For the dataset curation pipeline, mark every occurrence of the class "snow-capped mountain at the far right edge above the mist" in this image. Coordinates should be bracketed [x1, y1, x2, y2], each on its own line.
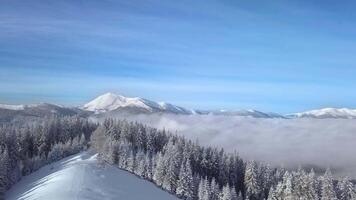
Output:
[287, 108, 356, 119]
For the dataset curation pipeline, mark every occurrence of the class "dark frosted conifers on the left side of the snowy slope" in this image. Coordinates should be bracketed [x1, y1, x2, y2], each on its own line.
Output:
[0, 117, 97, 199]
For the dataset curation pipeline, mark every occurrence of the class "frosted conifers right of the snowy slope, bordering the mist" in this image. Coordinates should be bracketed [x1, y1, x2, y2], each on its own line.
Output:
[91, 119, 356, 200]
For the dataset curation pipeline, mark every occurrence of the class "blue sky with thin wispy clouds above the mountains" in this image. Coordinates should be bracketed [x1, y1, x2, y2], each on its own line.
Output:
[0, 0, 356, 113]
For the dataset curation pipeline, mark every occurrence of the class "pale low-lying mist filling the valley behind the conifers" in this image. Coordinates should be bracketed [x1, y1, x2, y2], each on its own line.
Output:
[93, 114, 356, 178]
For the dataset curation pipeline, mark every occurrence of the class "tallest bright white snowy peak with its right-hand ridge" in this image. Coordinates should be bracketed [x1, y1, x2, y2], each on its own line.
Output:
[82, 93, 192, 114]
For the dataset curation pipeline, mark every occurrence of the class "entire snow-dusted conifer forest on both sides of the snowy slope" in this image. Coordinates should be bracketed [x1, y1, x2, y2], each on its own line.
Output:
[0, 117, 356, 200]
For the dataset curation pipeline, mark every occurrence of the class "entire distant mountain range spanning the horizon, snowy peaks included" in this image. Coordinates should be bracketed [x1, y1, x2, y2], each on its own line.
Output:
[0, 93, 356, 122]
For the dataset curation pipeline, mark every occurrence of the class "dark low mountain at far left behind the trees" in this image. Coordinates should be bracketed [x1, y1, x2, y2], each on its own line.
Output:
[0, 103, 89, 123]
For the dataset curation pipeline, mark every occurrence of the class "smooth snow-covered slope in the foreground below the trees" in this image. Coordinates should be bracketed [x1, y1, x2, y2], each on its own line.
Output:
[6, 152, 181, 200]
